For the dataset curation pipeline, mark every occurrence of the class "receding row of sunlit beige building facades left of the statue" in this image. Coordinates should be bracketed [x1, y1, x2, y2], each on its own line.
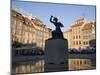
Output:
[11, 9, 51, 48]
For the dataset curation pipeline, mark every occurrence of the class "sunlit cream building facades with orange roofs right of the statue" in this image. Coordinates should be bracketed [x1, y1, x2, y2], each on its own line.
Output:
[64, 18, 96, 50]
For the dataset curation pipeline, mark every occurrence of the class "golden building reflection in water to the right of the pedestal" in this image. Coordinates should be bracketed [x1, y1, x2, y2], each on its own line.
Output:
[69, 59, 92, 70]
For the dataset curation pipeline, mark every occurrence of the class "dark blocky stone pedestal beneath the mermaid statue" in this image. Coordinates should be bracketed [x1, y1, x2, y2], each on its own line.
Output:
[45, 39, 68, 72]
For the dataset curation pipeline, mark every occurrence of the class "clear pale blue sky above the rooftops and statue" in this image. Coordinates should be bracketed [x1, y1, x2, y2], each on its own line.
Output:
[11, 1, 96, 32]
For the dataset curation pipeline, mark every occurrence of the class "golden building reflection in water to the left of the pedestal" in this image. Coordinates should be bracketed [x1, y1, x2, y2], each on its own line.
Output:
[15, 60, 44, 73]
